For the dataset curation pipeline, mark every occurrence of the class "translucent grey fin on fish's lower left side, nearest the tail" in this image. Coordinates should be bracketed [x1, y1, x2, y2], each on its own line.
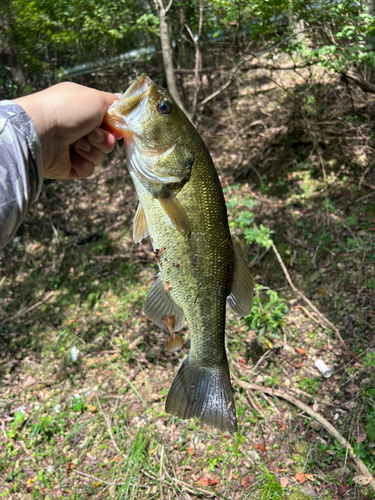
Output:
[143, 273, 185, 332]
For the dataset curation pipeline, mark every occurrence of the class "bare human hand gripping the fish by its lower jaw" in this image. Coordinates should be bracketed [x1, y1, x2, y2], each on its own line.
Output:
[14, 82, 121, 179]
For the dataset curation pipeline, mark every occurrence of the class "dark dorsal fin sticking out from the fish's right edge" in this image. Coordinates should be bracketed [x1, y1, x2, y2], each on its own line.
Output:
[227, 249, 254, 316]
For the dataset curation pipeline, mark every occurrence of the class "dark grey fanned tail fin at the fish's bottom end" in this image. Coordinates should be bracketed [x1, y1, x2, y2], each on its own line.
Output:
[165, 356, 237, 432]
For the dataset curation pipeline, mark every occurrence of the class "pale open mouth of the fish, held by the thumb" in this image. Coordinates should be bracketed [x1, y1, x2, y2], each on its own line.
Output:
[103, 73, 153, 132]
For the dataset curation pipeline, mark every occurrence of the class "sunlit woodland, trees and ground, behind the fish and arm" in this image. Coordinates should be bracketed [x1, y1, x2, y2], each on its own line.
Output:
[0, 0, 375, 500]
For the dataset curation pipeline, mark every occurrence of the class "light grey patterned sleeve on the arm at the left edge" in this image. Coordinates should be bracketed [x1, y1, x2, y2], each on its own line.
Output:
[0, 101, 43, 249]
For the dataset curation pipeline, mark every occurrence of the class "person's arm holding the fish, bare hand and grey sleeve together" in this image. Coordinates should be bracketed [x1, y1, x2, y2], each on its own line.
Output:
[0, 83, 116, 249]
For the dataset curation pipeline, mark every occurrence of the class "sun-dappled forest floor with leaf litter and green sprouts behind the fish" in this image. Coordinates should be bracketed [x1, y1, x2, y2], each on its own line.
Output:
[0, 67, 375, 500]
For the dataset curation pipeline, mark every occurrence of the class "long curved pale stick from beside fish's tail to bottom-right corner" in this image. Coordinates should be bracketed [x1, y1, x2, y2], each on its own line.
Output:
[237, 380, 375, 491]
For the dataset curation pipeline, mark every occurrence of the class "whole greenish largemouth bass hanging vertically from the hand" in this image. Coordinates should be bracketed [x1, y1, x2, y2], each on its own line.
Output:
[104, 74, 254, 432]
